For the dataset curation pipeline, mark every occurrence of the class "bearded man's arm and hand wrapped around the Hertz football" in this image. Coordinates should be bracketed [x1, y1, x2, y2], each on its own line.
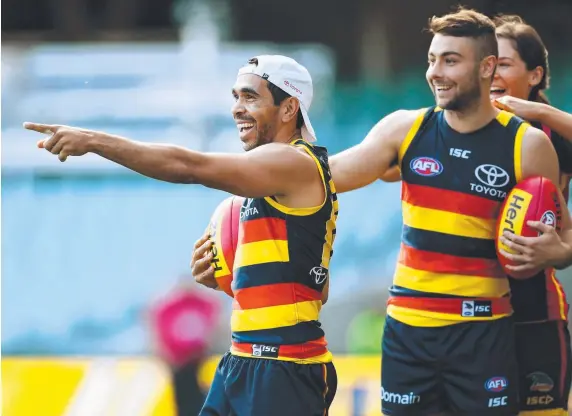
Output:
[501, 128, 572, 271]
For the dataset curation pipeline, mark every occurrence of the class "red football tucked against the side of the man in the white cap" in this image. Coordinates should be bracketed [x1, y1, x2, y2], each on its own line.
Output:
[209, 196, 244, 297]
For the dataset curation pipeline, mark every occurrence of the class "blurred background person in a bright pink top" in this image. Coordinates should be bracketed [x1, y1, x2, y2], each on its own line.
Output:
[148, 284, 220, 416]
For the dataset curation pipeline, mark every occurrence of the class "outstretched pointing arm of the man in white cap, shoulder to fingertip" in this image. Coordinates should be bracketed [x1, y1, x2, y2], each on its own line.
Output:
[24, 123, 317, 198]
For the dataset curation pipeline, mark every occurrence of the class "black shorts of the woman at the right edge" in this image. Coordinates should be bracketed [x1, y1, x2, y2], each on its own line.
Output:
[515, 321, 571, 415]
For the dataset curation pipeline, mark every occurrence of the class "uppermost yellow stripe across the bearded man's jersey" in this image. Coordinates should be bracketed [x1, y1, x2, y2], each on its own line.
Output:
[402, 201, 496, 240]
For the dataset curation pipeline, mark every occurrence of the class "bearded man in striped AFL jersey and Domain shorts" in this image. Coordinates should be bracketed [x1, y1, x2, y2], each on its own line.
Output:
[331, 10, 572, 416]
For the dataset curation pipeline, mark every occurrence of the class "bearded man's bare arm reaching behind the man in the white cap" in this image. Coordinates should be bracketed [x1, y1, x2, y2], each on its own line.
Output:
[330, 110, 420, 193]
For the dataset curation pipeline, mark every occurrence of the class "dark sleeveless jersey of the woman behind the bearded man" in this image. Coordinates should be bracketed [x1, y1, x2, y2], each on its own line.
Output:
[509, 123, 572, 323]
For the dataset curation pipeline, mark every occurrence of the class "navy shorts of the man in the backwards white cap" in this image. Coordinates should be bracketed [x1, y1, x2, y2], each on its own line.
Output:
[199, 353, 338, 416]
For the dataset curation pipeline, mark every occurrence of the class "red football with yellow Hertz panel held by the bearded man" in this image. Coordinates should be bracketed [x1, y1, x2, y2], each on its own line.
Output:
[496, 176, 562, 279]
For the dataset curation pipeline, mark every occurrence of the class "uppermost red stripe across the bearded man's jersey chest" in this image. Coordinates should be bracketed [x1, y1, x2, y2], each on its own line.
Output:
[401, 182, 501, 219]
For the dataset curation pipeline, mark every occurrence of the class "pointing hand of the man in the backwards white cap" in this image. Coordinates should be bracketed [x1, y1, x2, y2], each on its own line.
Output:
[24, 123, 96, 162]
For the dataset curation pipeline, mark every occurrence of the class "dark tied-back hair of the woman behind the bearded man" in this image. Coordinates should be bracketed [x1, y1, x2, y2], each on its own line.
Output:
[494, 15, 550, 104]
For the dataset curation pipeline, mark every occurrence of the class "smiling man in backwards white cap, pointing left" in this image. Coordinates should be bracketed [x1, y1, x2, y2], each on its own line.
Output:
[25, 55, 338, 416]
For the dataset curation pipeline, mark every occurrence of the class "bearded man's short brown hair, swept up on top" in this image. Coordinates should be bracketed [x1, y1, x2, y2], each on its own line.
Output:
[428, 7, 499, 59]
